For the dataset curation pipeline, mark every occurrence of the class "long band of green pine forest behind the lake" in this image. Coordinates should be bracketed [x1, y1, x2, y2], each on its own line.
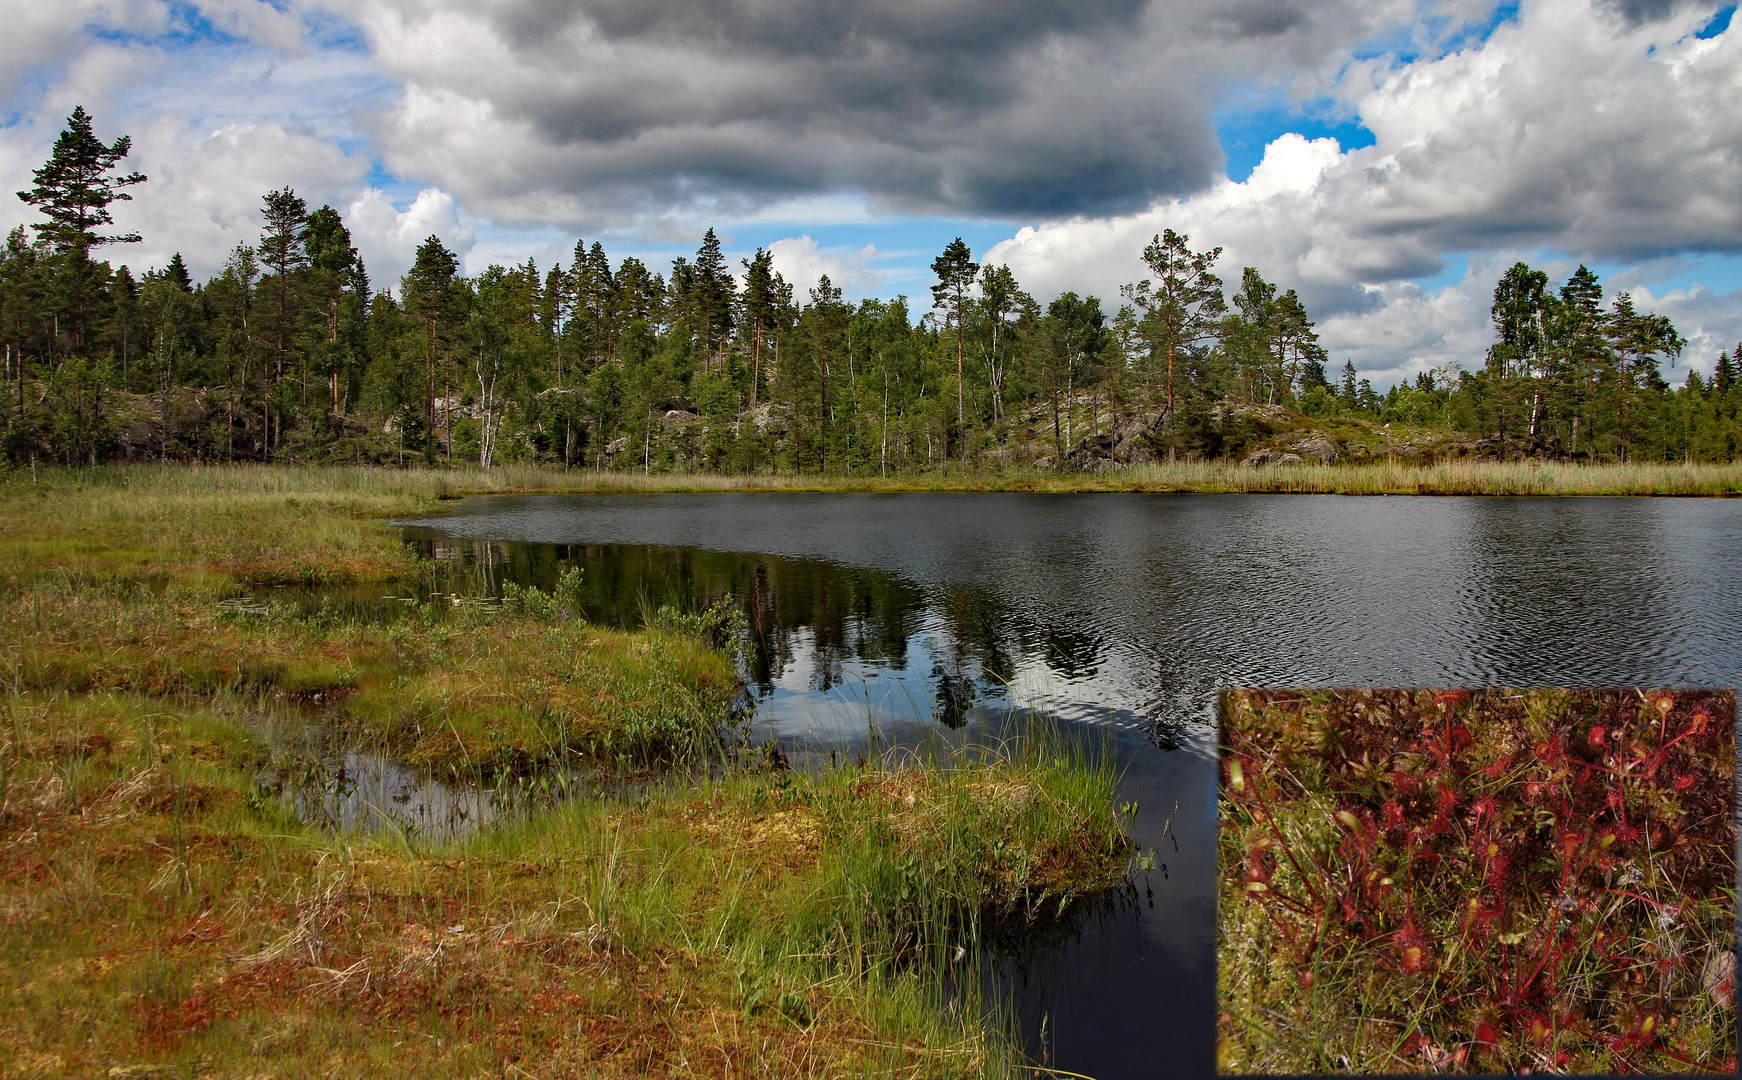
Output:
[10, 108, 1742, 476]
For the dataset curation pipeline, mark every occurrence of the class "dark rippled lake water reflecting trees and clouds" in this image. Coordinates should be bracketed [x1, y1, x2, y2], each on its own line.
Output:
[398, 495, 1742, 1080]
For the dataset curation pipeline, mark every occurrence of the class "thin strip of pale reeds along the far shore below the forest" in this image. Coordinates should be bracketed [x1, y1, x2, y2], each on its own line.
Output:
[7, 460, 1742, 501]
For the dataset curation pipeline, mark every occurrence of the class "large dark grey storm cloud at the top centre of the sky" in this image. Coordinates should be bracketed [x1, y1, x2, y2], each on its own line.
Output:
[376, 0, 1413, 218]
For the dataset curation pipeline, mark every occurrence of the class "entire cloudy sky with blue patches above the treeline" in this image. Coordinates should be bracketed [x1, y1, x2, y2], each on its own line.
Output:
[0, 0, 1742, 387]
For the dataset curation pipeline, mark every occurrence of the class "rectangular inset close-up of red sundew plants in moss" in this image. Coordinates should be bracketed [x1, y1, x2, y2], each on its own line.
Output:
[1218, 690, 1737, 1075]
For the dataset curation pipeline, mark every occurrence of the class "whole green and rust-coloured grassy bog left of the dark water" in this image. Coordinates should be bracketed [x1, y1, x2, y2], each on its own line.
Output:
[0, 469, 1131, 1078]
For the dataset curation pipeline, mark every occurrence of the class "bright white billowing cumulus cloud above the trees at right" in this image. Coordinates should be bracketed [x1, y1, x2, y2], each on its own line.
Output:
[986, 0, 1742, 381]
